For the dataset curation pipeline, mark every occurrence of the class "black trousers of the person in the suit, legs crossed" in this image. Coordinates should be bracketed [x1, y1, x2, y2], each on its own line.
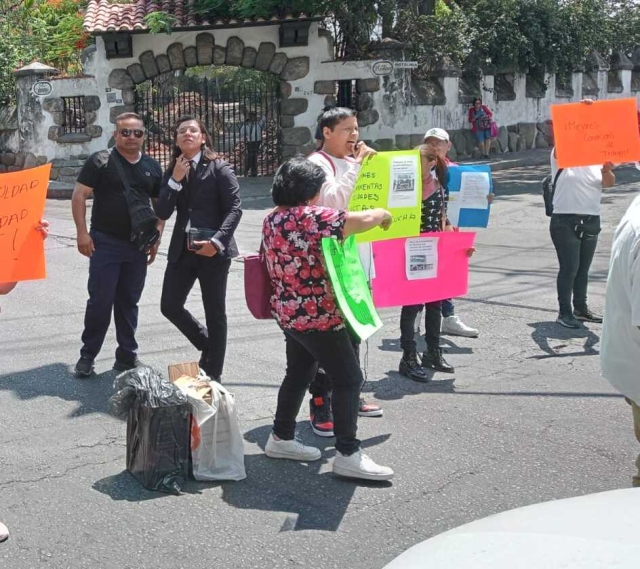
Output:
[160, 251, 231, 378]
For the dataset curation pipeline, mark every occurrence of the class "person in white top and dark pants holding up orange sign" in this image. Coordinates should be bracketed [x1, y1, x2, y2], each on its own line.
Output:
[549, 138, 616, 328]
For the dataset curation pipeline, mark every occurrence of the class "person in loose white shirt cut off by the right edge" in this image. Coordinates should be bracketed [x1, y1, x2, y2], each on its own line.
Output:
[600, 196, 640, 487]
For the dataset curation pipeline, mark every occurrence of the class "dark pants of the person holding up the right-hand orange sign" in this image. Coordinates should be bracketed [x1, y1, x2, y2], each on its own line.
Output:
[549, 214, 600, 315]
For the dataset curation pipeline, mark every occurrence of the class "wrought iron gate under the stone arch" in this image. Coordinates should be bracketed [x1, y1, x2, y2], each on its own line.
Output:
[136, 72, 281, 176]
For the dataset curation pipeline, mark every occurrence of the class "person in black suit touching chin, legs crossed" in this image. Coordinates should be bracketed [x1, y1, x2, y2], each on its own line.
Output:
[156, 116, 242, 381]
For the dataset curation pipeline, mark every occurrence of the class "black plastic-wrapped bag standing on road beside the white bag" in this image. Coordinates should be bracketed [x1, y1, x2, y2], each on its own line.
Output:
[109, 366, 191, 494]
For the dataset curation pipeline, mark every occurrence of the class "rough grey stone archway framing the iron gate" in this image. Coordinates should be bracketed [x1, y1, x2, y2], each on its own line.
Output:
[108, 32, 313, 170]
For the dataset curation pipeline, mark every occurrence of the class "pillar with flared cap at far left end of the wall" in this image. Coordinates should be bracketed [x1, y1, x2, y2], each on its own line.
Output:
[14, 62, 59, 158]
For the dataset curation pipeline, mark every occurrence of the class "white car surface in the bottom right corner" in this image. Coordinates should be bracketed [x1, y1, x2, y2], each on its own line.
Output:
[384, 488, 640, 569]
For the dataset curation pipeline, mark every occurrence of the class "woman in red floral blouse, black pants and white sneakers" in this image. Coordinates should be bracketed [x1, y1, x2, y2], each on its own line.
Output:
[263, 157, 393, 480]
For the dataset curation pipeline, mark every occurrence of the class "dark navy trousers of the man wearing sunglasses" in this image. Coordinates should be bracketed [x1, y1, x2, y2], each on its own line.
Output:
[80, 231, 147, 363]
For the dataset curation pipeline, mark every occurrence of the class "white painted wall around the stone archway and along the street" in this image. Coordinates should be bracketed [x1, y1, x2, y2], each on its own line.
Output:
[12, 23, 640, 159]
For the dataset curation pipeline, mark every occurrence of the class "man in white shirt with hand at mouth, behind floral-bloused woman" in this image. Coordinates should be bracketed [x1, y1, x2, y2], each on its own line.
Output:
[308, 107, 382, 437]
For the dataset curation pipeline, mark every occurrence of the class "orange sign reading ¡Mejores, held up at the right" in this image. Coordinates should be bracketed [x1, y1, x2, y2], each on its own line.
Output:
[551, 99, 640, 168]
